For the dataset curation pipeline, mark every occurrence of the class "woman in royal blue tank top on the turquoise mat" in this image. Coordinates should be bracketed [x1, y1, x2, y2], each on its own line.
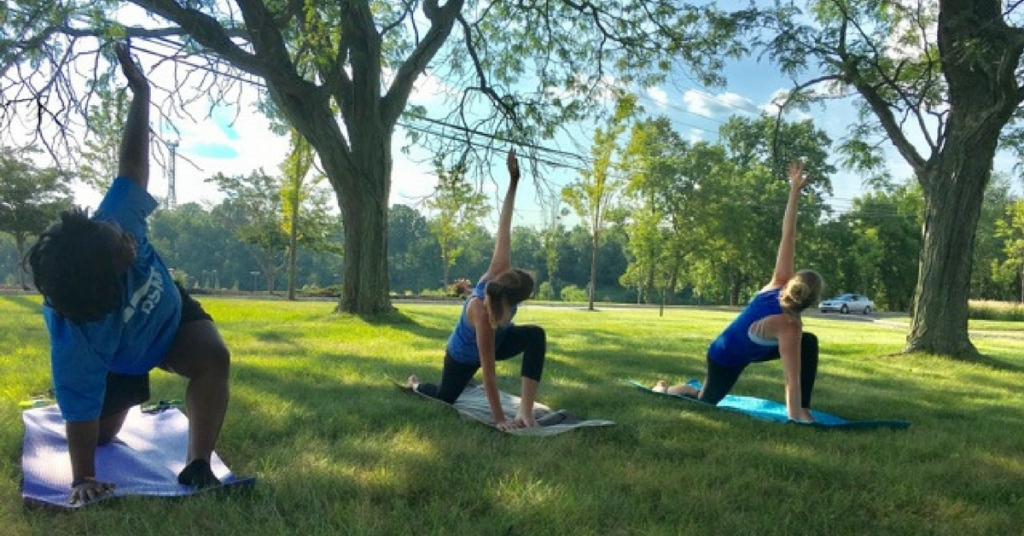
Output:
[653, 163, 823, 422]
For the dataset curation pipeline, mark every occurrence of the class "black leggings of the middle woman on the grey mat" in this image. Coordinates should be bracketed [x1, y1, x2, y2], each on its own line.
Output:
[417, 326, 548, 404]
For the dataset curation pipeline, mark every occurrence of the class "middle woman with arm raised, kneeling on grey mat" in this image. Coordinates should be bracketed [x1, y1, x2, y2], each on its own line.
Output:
[407, 151, 547, 430]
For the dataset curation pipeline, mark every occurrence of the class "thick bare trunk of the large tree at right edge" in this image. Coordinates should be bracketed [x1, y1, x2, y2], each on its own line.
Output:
[906, 0, 1024, 358]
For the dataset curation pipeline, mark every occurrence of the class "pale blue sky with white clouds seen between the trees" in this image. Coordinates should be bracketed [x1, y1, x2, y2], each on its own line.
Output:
[51, 9, 1015, 226]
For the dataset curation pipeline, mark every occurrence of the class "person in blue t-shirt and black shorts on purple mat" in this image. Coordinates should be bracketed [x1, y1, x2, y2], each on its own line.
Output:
[27, 45, 229, 503]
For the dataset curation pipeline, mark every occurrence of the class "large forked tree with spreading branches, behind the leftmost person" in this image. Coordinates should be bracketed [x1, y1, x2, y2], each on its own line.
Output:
[0, 0, 751, 314]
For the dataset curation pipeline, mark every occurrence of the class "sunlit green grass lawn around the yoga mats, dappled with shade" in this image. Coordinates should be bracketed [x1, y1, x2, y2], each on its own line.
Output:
[0, 296, 1024, 535]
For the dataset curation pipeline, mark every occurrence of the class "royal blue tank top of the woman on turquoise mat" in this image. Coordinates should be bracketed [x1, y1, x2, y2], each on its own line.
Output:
[708, 288, 782, 367]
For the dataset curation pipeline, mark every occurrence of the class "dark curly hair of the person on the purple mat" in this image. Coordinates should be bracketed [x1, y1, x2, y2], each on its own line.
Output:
[23, 208, 135, 323]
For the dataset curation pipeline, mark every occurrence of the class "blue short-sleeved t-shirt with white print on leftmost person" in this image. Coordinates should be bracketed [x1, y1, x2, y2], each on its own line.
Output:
[43, 177, 181, 421]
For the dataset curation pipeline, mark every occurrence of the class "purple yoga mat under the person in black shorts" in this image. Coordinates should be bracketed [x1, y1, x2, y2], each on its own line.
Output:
[22, 406, 256, 508]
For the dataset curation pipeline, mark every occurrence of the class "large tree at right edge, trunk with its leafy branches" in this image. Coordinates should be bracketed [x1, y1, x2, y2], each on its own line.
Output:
[761, 0, 1024, 357]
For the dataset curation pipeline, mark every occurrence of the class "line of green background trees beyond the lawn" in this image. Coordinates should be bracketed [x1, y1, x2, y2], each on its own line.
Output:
[6, 117, 1024, 311]
